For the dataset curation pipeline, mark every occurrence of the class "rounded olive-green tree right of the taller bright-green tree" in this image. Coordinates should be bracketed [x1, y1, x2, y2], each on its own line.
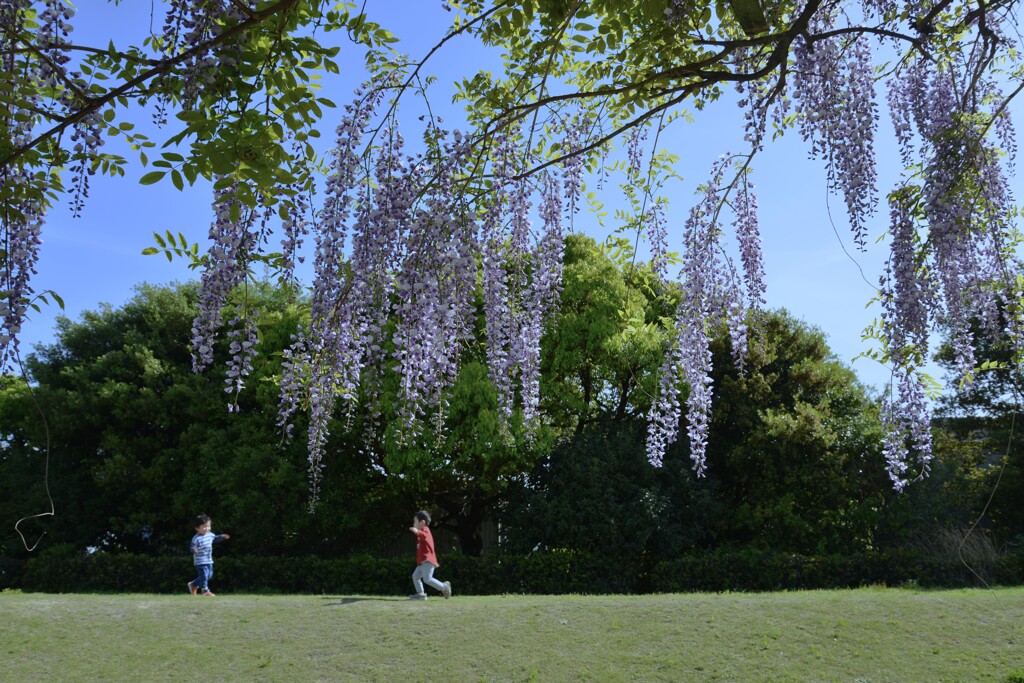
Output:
[712, 311, 893, 552]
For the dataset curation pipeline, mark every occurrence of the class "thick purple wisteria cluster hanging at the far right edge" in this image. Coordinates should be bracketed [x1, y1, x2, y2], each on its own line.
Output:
[881, 53, 1021, 475]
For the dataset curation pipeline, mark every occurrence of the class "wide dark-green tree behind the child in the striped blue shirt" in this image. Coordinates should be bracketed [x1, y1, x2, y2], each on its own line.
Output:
[0, 285, 412, 555]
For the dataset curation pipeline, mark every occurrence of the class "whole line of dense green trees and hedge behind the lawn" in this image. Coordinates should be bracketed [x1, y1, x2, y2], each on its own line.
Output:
[0, 236, 1024, 581]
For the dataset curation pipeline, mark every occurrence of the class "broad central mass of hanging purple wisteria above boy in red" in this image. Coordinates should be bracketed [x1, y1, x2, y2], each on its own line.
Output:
[268, 88, 581, 502]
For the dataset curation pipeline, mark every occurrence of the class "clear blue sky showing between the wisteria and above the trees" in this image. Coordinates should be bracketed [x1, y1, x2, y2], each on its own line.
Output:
[23, 0, 958, 395]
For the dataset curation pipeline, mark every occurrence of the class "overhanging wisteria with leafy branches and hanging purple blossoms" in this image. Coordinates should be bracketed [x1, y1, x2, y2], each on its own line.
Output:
[0, 0, 1022, 492]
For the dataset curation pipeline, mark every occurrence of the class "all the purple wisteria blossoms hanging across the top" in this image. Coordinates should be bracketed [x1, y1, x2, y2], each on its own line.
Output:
[0, 0, 1024, 496]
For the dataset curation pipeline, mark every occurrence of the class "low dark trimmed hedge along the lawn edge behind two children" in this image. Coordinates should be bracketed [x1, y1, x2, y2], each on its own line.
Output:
[0, 549, 1024, 595]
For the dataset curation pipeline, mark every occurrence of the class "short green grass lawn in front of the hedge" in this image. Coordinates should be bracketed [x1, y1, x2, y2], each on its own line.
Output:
[0, 587, 1024, 683]
